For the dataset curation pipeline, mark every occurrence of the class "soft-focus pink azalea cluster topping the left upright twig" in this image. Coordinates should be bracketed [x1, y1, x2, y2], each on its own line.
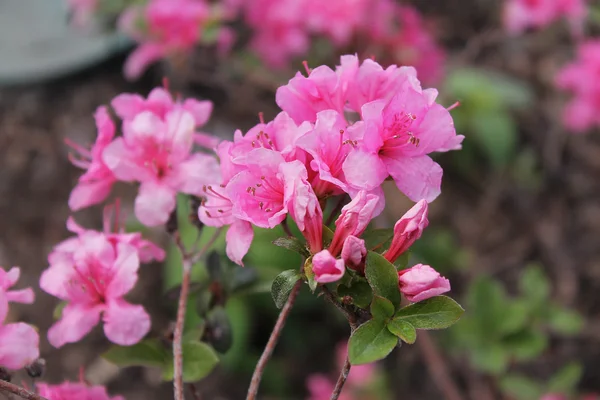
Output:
[69, 88, 219, 226]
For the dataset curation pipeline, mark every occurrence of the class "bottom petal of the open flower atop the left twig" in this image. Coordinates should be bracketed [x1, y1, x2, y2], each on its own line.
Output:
[135, 182, 176, 226]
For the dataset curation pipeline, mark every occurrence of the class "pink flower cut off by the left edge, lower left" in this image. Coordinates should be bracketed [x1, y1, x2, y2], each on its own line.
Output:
[0, 267, 40, 369]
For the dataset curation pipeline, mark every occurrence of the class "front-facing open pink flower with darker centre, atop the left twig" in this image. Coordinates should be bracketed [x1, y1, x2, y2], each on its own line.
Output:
[103, 109, 219, 226]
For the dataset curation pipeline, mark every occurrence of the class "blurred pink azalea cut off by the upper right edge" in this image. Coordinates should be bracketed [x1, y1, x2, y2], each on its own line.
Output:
[556, 40, 600, 133]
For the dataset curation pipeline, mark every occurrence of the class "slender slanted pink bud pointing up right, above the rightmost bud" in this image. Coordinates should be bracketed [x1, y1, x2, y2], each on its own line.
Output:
[384, 200, 429, 263]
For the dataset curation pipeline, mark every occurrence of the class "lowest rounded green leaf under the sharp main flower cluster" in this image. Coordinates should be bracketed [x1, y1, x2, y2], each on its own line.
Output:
[348, 319, 398, 365]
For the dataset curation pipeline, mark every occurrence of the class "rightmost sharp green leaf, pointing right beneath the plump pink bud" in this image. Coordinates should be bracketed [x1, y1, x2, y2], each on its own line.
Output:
[392, 296, 465, 329]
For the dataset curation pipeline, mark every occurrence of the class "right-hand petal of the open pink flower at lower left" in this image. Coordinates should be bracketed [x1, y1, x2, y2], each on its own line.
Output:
[105, 243, 140, 299]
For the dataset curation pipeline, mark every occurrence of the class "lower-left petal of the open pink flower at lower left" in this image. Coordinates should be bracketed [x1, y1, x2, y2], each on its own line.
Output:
[48, 303, 104, 348]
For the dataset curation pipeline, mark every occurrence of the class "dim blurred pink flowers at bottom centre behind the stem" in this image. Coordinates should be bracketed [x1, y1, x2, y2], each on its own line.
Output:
[306, 343, 377, 400]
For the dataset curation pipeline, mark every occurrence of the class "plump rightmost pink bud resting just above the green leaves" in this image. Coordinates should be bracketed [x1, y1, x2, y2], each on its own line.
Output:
[398, 264, 450, 303]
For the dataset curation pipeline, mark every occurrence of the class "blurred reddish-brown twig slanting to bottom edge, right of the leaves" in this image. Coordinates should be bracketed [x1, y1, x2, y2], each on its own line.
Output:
[417, 331, 464, 400]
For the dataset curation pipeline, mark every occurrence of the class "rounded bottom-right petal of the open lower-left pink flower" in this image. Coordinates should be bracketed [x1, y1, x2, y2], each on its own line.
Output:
[104, 300, 150, 346]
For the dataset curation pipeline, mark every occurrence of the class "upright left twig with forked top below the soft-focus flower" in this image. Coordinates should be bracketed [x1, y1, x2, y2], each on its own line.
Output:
[173, 228, 221, 400]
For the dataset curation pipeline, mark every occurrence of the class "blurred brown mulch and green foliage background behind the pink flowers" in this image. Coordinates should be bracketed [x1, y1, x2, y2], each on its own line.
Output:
[0, 0, 600, 400]
